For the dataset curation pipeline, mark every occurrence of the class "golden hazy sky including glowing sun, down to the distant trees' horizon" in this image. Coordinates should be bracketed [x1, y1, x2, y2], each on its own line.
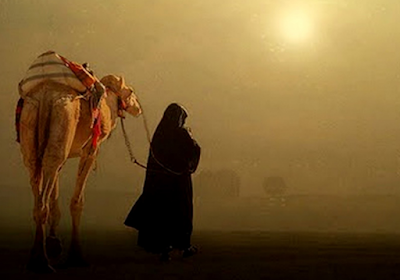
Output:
[0, 0, 400, 194]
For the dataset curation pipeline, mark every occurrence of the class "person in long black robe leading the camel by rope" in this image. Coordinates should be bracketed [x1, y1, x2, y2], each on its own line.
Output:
[125, 103, 200, 260]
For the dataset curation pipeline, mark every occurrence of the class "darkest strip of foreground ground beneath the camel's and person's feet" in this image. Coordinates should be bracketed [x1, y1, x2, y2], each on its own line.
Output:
[0, 229, 400, 279]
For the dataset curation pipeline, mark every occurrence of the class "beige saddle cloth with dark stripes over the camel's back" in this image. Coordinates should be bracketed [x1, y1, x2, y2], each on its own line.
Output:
[19, 51, 96, 98]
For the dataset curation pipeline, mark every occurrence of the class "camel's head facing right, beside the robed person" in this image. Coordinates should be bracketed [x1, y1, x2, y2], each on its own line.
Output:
[100, 75, 142, 117]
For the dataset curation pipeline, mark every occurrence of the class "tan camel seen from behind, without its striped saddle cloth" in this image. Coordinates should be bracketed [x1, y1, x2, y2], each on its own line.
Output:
[19, 53, 141, 273]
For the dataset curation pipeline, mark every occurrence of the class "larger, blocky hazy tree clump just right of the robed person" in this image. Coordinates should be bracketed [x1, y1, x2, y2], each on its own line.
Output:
[194, 170, 240, 198]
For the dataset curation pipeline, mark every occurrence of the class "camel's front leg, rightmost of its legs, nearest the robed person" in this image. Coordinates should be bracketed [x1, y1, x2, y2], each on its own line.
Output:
[68, 146, 97, 266]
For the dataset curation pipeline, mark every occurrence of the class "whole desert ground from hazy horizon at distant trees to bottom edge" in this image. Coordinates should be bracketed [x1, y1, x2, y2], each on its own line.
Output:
[0, 188, 400, 279]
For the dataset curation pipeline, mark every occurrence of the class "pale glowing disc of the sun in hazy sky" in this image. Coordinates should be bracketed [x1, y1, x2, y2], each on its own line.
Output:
[279, 10, 313, 43]
